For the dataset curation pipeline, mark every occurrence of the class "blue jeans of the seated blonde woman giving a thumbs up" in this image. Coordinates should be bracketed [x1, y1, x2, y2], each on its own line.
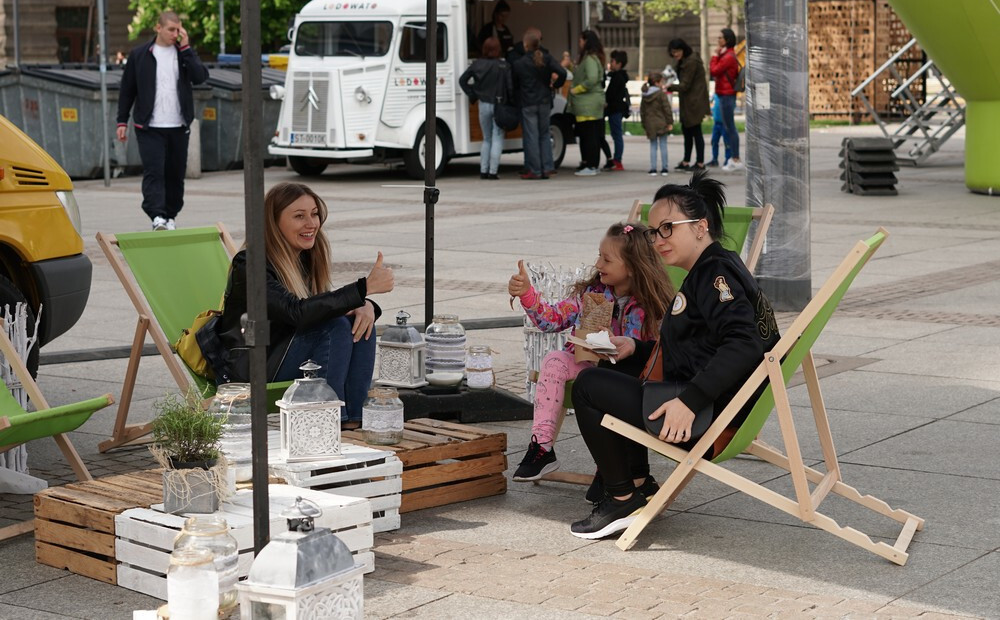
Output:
[274, 316, 375, 422]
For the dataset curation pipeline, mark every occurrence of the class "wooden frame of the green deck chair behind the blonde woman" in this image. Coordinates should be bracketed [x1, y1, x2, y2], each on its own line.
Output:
[97, 222, 237, 452]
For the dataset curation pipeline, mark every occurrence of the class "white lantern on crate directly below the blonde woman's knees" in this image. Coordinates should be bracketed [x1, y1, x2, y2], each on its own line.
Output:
[278, 360, 344, 462]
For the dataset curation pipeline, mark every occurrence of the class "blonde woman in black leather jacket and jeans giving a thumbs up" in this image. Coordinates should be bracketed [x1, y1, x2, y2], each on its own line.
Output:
[207, 183, 393, 428]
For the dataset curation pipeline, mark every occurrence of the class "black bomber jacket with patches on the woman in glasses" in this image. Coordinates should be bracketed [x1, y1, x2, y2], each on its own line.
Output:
[626, 242, 780, 426]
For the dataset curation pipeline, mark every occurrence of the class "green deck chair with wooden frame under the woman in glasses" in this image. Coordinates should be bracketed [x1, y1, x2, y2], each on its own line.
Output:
[602, 228, 924, 565]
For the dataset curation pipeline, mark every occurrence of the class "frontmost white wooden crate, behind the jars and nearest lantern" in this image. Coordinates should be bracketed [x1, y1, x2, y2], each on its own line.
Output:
[115, 484, 375, 600]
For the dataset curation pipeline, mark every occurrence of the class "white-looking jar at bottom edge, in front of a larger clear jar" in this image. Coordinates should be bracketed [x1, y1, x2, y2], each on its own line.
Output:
[167, 548, 219, 620]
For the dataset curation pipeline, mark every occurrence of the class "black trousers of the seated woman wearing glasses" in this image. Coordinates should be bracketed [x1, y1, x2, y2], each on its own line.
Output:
[573, 368, 649, 496]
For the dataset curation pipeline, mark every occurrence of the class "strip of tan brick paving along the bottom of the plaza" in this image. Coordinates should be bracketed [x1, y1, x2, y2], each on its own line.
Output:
[371, 533, 969, 620]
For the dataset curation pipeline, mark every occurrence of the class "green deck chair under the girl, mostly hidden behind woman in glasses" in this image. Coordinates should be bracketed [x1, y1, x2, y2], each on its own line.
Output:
[536, 200, 774, 485]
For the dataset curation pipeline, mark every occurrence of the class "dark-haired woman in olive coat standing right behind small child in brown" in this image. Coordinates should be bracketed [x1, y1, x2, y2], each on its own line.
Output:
[667, 39, 711, 170]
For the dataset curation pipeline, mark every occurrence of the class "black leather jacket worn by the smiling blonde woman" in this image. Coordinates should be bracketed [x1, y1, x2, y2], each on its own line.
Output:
[215, 250, 382, 383]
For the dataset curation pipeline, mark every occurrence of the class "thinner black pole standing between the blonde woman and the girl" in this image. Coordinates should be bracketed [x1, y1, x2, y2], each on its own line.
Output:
[424, 0, 443, 325]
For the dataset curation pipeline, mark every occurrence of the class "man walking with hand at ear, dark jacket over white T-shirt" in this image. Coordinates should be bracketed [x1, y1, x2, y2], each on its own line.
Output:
[118, 11, 208, 230]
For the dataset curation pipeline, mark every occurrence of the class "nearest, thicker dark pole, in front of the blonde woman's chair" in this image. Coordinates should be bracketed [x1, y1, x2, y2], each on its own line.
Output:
[240, 0, 270, 555]
